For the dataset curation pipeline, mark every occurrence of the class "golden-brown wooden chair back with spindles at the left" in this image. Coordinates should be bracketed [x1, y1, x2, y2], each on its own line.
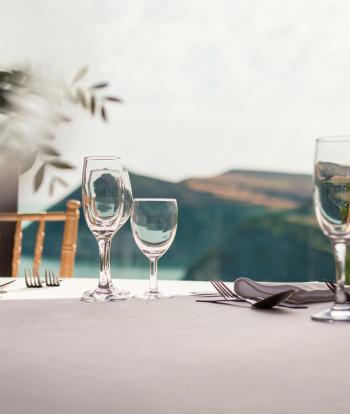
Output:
[0, 200, 80, 277]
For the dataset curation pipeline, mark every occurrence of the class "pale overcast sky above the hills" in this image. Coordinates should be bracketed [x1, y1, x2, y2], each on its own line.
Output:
[0, 0, 350, 206]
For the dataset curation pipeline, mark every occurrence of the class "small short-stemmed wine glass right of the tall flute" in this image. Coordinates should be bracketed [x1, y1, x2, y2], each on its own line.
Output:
[130, 198, 178, 299]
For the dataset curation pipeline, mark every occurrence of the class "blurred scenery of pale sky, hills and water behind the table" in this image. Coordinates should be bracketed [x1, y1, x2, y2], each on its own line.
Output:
[0, 0, 350, 281]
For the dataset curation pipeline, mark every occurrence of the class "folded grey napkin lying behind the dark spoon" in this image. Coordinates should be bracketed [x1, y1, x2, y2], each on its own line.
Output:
[234, 277, 334, 304]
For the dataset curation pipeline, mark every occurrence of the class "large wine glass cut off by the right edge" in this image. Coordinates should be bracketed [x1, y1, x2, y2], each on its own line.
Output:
[312, 136, 350, 321]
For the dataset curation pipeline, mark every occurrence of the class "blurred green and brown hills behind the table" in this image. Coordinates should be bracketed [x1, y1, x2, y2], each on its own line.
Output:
[23, 171, 332, 280]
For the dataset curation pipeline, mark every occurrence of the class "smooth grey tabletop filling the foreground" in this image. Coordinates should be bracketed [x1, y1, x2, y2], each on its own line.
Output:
[0, 297, 350, 414]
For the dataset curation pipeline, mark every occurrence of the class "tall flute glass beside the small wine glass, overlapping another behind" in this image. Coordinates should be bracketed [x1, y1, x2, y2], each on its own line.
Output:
[81, 157, 126, 302]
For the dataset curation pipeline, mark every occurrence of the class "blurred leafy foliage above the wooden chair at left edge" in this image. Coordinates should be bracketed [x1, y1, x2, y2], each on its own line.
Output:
[0, 66, 121, 193]
